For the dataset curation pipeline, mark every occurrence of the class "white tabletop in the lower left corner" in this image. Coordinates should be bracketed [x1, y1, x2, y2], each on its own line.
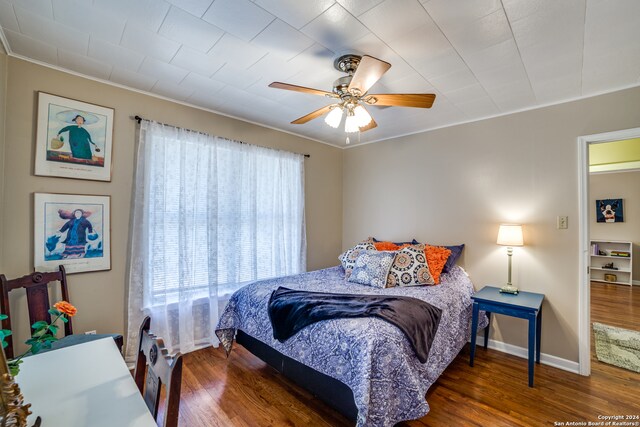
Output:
[16, 338, 156, 427]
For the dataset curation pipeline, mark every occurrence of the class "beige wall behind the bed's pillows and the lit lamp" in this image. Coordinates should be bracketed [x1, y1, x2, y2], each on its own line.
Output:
[342, 88, 640, 361]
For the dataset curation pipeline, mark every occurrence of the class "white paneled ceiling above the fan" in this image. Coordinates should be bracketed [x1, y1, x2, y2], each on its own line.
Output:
[0, 0, 640, 146]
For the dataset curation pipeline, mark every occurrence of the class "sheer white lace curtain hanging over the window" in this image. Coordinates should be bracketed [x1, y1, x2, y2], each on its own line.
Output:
[126, 121, 306, 361]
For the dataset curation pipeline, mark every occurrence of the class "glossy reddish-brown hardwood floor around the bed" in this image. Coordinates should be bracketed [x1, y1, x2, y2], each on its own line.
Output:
[171, 282, 640, 427]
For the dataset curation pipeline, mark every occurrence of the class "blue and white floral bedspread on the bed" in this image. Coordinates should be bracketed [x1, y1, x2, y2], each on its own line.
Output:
[216, 266, 487, 427]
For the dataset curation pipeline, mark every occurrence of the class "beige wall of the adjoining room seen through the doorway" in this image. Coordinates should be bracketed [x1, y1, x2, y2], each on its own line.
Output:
[589, 171, 640, 280]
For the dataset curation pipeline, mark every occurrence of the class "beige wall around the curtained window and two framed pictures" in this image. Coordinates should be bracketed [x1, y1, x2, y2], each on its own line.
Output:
[2, 58, 342, 352]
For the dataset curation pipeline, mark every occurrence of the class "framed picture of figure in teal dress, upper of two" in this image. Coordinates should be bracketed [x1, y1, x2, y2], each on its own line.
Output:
[35, 92, 114, 181]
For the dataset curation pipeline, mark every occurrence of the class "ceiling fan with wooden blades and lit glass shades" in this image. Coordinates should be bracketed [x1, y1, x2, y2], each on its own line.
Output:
[269, 54, 436, 133]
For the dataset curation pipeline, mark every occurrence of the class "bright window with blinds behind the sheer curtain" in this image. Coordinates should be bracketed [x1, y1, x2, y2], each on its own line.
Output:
[149, 141, 304, 304]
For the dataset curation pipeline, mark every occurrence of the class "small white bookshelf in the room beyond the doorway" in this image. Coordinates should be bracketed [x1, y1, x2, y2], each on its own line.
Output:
[589, 240, 633, 286]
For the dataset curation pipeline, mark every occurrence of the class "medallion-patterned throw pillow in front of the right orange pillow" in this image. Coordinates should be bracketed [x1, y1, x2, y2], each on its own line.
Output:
[387, 245, 435, 288]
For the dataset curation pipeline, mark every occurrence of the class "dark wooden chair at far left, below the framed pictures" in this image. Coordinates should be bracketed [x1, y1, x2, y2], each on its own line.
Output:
[0, 265, 123, 359]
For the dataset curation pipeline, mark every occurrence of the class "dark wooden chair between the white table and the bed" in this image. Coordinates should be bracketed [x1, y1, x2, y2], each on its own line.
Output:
[133, 316, 182, 427]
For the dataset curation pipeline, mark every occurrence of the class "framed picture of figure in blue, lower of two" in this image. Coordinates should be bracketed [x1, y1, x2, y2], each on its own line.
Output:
[33, 193, 111, 273]
